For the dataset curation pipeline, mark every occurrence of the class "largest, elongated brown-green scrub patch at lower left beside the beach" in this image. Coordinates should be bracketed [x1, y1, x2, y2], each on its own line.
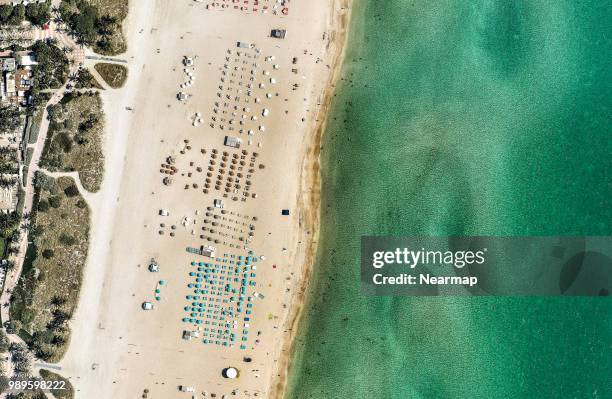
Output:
[10, 173, 89, 362]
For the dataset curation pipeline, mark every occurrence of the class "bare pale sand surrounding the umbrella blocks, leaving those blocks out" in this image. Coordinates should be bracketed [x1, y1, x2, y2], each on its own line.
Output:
[60, 0, 350, 398]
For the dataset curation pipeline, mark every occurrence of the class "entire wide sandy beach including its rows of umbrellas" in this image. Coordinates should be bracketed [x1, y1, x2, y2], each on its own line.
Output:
[59, 0, 347, 398]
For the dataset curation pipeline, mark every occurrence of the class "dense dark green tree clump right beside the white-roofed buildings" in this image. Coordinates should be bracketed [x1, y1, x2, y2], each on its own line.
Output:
[32, 41, 69, 90]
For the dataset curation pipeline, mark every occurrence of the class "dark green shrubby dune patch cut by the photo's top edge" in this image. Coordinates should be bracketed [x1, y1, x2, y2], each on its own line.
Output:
[60, 0, 128, 55]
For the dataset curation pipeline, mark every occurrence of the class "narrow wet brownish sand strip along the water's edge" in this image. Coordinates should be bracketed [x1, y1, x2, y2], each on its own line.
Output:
[269, 0, 353, 399]
